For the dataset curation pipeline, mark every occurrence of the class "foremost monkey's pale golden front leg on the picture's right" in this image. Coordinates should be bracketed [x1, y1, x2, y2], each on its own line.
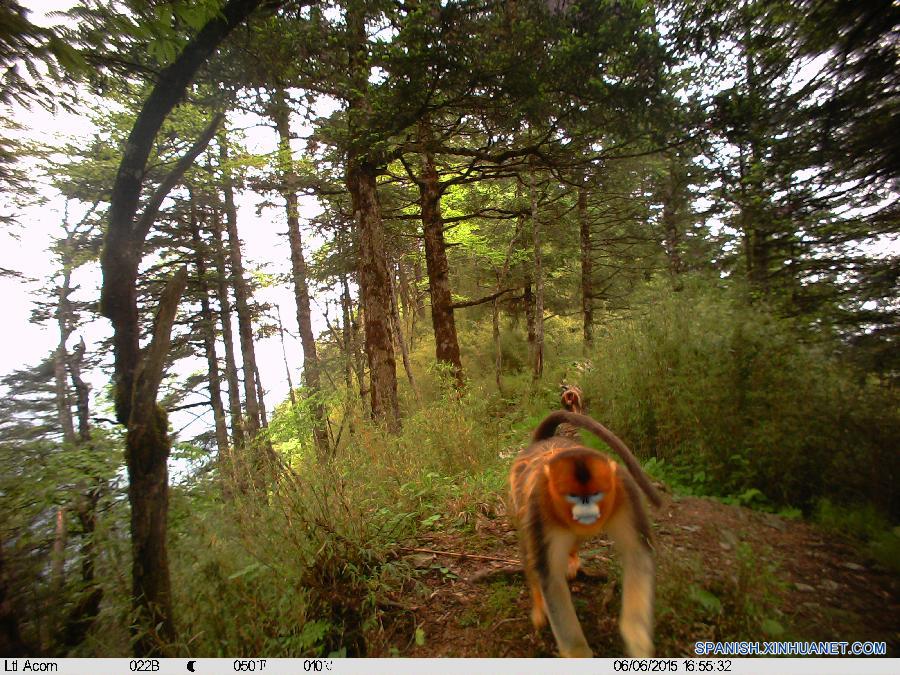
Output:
[606, 502, 654, 658]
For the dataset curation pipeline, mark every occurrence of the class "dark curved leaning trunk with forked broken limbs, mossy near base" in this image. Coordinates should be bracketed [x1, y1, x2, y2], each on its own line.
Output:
[100, 0, 260, 656]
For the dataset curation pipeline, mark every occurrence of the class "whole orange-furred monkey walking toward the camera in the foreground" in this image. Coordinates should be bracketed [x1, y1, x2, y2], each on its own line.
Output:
[510, 413, 654, 656]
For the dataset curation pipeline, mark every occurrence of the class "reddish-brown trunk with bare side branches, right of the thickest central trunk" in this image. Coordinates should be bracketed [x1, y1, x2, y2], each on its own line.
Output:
[418, 147, 463, 388]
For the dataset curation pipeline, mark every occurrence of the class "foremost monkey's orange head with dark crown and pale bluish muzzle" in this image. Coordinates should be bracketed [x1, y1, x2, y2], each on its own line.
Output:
[545, 448, 616, 535]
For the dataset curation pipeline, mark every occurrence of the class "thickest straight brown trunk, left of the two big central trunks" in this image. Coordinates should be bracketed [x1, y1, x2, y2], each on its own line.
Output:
[347, 159, 400, 432]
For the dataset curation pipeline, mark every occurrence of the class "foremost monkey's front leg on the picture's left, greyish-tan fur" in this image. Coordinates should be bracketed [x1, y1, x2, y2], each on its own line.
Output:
[537, 529, 593, 657]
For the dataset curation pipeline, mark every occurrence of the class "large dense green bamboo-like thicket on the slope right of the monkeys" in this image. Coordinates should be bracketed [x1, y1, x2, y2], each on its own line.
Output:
[583, 276, 900, 517]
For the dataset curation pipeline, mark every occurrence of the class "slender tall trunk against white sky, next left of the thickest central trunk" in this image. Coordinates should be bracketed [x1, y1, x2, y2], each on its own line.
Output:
[271, 89, 331, 460]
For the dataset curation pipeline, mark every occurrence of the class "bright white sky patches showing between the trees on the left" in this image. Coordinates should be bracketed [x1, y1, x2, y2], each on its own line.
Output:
[0, 0, 334, 446]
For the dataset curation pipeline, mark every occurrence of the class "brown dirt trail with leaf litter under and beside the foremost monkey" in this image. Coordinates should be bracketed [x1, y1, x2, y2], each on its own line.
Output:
[369, 496, 900, 657]
